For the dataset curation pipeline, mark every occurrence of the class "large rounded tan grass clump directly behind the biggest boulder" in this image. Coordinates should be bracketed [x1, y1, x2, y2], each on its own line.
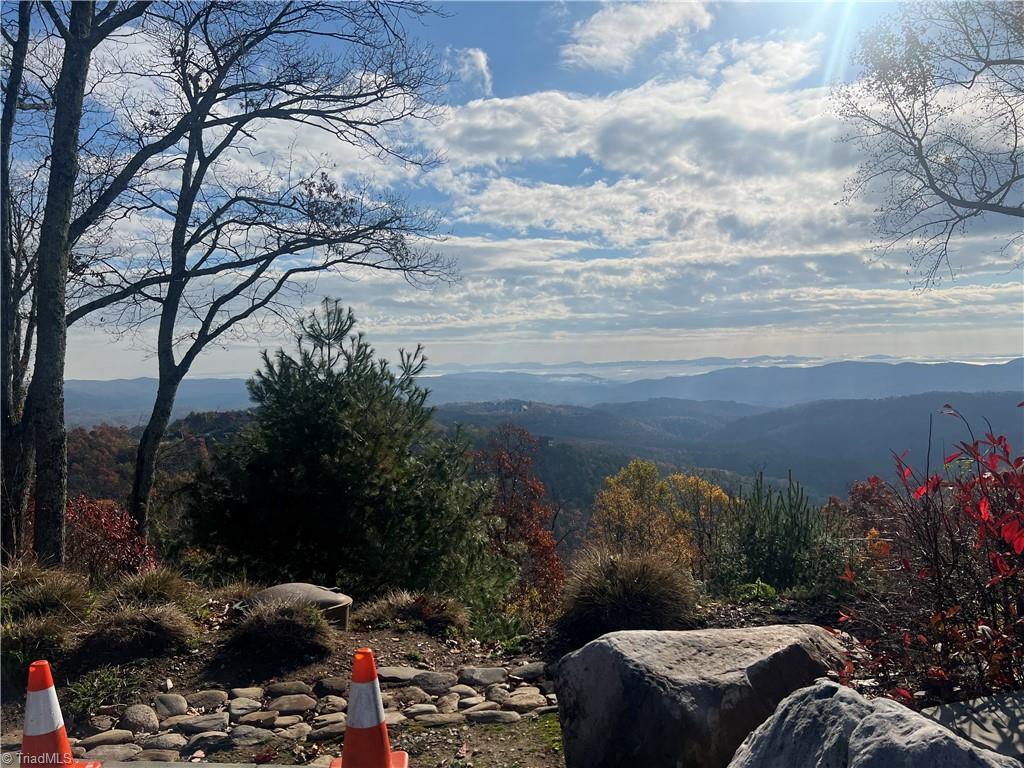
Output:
[557, 548, 696, 645]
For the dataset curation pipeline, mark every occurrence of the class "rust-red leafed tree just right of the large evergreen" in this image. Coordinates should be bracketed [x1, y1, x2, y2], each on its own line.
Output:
[476, 424, 564, 617]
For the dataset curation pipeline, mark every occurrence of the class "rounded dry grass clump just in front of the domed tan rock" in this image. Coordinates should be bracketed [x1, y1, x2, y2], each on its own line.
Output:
[226, 601, 333, 666]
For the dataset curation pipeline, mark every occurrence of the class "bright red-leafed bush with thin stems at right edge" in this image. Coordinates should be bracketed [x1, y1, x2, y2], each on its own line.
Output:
[843, 403, 1024, 701]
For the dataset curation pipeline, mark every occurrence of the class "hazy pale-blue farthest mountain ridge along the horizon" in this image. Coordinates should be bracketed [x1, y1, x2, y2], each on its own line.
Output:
[65, 358, 1024, 426]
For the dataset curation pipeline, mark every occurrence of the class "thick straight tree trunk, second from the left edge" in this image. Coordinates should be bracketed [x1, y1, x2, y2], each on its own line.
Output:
[29, 1, 95, 564]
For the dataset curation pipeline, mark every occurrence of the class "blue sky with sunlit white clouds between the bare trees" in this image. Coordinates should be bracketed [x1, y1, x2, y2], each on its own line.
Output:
[67, 2, 1024, 379]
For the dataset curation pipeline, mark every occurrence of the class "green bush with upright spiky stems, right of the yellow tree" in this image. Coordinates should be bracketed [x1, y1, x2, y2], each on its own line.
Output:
[708, 474, 851, 595]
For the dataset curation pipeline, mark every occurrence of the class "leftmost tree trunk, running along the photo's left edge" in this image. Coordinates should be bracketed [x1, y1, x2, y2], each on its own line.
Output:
[0, 2, 32, 562]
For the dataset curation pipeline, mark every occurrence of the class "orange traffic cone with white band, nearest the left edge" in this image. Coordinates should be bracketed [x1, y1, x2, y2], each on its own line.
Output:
[22, 662, 101, 768]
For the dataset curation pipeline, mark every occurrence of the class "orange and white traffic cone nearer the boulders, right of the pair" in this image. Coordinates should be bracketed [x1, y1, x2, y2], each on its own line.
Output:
[331, 648, 409, 768]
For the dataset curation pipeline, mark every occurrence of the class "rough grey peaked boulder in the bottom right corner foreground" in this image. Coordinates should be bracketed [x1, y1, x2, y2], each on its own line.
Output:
[729, 680, 1021, 768]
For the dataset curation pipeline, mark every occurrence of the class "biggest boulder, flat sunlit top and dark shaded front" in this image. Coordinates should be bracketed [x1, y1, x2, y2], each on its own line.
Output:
[557, 625, 844, 768]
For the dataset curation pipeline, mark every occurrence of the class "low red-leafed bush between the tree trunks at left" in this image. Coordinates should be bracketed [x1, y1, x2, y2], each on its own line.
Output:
[67, 496, 157, 582]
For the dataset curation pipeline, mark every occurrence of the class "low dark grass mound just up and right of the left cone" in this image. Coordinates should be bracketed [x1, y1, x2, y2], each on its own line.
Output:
[79, 604, 197, 664]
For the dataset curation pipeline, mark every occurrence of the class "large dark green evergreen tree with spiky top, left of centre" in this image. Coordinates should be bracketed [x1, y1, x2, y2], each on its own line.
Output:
[190, 301, 507, 597]
